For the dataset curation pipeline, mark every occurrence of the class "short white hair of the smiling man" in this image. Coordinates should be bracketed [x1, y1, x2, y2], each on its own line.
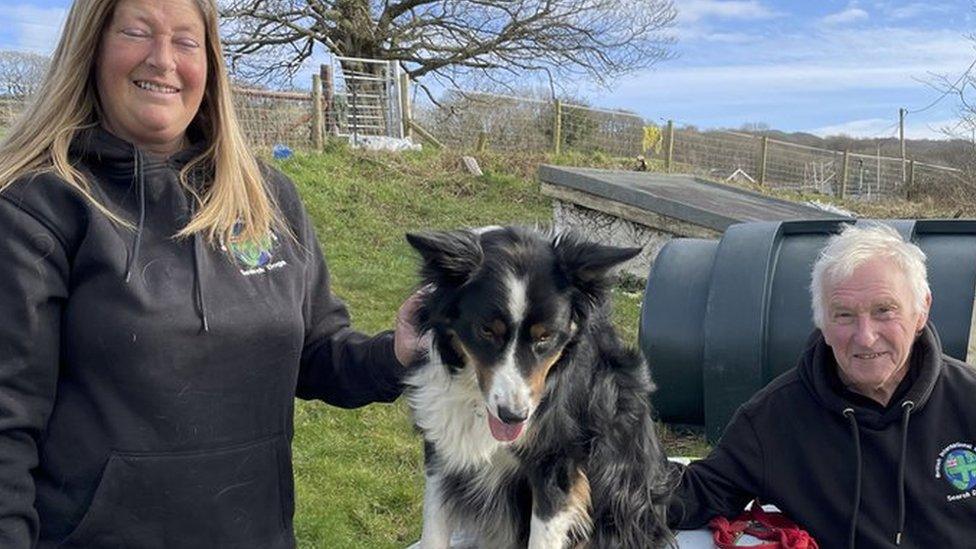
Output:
[810, 223, 930, 329]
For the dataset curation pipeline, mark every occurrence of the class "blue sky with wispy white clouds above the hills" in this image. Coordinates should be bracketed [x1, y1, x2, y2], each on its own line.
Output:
[0, 0, 976, 137]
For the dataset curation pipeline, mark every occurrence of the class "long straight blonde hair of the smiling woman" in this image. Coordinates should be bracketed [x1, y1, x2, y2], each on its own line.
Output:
[0, 0, 284, 243]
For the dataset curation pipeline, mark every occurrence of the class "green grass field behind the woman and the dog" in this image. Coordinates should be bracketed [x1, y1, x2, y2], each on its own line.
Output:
[277, 146, 704, 549]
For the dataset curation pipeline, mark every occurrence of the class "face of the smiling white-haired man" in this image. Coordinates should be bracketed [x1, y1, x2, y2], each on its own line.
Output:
[823, 258, 931, 396]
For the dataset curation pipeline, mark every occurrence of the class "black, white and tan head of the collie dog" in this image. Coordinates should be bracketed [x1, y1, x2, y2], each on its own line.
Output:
[407, 227, 640, 442]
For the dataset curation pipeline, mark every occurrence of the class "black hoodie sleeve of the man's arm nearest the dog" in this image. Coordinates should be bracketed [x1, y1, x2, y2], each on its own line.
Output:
[668, 408, 765, 529]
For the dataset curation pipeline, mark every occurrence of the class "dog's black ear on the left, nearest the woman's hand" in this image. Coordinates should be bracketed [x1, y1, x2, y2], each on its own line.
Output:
[407, 231, 484, 287]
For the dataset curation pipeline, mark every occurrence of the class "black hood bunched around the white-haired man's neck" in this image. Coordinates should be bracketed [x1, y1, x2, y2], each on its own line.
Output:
[797, 323, 942, 429]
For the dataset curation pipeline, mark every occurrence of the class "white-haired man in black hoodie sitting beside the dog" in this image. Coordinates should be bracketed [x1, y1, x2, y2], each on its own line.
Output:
[669, 225, 976, 548]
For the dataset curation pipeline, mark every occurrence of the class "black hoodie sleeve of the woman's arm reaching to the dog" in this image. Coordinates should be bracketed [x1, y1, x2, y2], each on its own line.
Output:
[296, 193, 406, 408]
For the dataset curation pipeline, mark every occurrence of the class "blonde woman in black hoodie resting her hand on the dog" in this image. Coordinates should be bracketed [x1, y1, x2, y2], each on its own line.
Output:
[0, 0, 418, 549]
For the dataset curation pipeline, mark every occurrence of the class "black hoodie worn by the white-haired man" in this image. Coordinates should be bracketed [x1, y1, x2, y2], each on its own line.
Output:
[669, 324, 976, 549]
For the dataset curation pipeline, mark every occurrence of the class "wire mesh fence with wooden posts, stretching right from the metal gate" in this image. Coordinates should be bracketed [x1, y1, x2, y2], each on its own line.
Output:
[414, 90, 962, 200]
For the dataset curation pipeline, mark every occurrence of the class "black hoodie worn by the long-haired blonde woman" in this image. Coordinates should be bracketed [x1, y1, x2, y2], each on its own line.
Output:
[0, 126, 402, 549]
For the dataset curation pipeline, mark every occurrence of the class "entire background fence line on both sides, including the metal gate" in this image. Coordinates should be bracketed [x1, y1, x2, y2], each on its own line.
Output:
[0, 69, 962, 199]
